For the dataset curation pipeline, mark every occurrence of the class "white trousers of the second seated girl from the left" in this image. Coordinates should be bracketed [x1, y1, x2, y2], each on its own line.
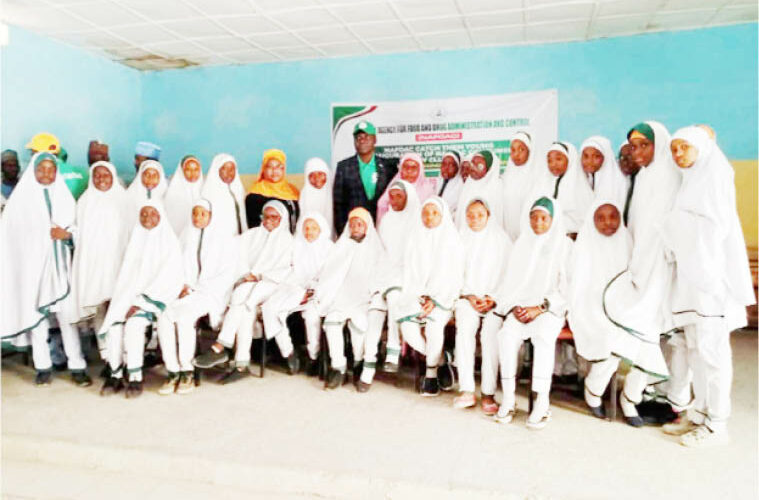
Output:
[158, 293, 209, 374]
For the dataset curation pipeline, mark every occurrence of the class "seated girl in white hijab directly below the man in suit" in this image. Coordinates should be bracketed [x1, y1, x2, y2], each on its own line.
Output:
[313, 207, 384, 389]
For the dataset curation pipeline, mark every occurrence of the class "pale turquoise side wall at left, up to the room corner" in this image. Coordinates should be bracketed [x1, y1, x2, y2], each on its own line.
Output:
[0, 27, 143, 180]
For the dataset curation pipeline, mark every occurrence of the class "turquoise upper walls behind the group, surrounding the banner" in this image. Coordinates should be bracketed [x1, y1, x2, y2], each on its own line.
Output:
[2, 23, 759, 178]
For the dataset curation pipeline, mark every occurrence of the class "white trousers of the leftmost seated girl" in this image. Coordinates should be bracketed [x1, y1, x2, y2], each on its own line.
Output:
[107, 315, 150, 381]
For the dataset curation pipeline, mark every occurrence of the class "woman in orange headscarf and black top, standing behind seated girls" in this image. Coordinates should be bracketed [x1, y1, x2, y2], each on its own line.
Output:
[245, 149, 300, 233]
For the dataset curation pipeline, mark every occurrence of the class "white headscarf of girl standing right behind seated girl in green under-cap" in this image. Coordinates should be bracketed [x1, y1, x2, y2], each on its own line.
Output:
[524, 142, 593, 233]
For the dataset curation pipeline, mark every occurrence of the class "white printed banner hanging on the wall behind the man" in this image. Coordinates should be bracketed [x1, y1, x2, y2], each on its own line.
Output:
[332, 89, 559, 176]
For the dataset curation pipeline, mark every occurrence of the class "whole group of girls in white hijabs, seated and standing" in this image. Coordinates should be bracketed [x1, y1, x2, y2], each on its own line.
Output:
[0, 121, 754, 446]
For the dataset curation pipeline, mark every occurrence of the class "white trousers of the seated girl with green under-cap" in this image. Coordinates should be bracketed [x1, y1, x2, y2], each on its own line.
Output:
[498, 313, 564, 395]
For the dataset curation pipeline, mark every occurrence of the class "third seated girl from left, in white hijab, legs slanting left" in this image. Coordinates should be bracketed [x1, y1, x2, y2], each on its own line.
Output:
[193, 200, 298, 383]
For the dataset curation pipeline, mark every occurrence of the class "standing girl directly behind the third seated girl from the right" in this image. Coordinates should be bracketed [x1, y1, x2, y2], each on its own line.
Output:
[455, 150, 503, 230]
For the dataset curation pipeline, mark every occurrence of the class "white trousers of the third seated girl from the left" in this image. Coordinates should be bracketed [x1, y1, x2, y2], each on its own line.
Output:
[216, 281, 277, 368]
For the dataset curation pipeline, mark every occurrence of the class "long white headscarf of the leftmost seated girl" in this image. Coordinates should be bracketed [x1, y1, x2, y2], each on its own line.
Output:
[99, 200, 185, 335]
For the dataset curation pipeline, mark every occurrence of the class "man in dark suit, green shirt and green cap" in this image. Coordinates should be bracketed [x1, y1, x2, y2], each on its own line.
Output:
[332, 121, 398, 235]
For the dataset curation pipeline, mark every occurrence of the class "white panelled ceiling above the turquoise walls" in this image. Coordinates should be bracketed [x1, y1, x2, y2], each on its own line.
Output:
[0, 0, 757, 69]
